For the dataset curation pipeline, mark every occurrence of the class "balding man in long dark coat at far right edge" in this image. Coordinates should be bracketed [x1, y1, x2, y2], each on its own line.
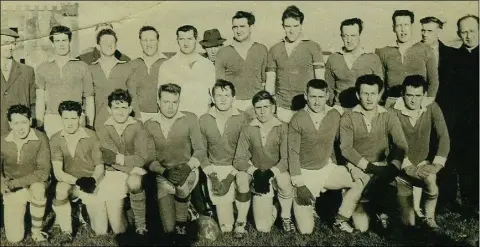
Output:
[450, 15, 479, 218]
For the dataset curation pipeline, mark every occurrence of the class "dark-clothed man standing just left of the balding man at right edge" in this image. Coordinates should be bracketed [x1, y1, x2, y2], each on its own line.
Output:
[415, 16, 458, 213]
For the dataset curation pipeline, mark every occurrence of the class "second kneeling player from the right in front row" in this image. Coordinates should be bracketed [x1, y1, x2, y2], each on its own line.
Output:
[340, 74, 408, 233]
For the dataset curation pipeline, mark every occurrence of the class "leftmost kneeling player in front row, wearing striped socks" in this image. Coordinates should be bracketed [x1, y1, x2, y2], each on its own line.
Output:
[0, 105, 51, 243]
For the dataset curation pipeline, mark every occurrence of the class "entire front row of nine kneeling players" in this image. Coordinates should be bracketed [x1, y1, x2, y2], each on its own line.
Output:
[1, 75, 449, 242]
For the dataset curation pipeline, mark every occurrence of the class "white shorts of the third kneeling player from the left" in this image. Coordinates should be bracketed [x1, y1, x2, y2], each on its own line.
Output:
[97, 171, 128, 201]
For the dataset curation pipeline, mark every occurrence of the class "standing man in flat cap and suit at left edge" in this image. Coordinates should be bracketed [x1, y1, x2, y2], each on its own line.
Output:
[0, 28, 35, 135]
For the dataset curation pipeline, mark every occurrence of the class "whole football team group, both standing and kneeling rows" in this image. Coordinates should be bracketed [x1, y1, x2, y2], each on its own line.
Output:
[1, 3, 479, 244]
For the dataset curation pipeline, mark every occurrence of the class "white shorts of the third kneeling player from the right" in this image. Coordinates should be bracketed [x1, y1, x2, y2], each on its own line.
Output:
[301, 161, 337, 197]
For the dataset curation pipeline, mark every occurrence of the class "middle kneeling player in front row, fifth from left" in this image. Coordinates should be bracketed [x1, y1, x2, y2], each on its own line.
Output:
[200, 79, 250, 232]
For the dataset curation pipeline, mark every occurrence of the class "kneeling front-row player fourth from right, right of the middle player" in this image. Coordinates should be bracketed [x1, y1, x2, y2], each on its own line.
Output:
[233, 91, 295, 237]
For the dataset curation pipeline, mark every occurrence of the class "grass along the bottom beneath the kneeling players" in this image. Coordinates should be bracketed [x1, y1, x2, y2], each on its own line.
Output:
[1, 199, 479, 246]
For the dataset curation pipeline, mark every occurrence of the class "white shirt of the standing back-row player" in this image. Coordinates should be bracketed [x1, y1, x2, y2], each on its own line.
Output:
[158, 52, 215, 117]
